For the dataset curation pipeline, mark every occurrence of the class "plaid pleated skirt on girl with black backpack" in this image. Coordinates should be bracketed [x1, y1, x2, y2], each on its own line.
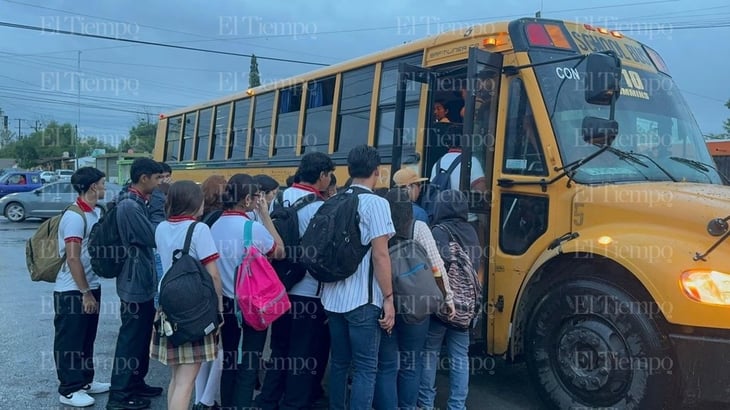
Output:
[150, 329, 218, 366]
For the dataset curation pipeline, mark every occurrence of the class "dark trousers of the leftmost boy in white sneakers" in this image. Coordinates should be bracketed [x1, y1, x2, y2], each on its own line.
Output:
[53, 289, 101, 396]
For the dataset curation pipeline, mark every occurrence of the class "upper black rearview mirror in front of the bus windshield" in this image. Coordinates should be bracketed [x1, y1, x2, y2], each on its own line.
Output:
[585, 52, 621, 105]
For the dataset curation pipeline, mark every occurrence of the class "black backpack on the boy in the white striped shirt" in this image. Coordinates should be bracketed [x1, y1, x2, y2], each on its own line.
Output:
[301, 187, 372, 282]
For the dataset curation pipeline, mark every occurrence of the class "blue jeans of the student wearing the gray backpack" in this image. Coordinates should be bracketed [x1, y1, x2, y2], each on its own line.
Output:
[373, 316, 429, 410]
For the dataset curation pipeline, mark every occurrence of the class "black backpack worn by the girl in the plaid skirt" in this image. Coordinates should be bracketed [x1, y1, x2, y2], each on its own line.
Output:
[160, 222, 220, 347]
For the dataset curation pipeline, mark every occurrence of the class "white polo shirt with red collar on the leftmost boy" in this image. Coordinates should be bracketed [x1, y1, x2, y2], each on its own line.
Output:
[53, 198, 101, 292]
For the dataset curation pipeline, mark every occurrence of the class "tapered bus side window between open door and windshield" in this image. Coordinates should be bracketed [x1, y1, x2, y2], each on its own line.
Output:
[502, 78, 547, 175]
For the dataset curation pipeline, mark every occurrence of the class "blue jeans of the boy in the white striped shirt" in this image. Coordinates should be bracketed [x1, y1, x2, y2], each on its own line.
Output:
[327, 303, 382, 410]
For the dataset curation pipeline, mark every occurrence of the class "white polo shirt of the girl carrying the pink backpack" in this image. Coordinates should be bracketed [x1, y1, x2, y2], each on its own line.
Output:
[210, 211, 276, 299]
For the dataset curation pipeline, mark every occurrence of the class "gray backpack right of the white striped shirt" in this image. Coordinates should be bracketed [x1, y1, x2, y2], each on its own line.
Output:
[388, 221, 443, 324]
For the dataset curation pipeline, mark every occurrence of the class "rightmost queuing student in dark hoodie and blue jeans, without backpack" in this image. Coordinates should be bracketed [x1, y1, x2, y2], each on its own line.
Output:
[418, 190, 480, 410]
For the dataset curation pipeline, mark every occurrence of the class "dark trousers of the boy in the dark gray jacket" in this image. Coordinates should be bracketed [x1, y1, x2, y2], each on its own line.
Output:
[109, 300, 155, 401]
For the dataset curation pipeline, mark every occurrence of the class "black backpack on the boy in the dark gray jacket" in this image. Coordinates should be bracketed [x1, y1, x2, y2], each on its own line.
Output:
[88, 199, 123, 279]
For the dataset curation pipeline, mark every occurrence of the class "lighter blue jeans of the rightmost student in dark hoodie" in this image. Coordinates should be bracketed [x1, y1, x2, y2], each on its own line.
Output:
[418, 317, 469, 410]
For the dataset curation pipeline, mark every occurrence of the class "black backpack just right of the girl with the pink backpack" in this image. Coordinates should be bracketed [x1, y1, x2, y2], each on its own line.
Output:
[271, 194, 322, 291]
